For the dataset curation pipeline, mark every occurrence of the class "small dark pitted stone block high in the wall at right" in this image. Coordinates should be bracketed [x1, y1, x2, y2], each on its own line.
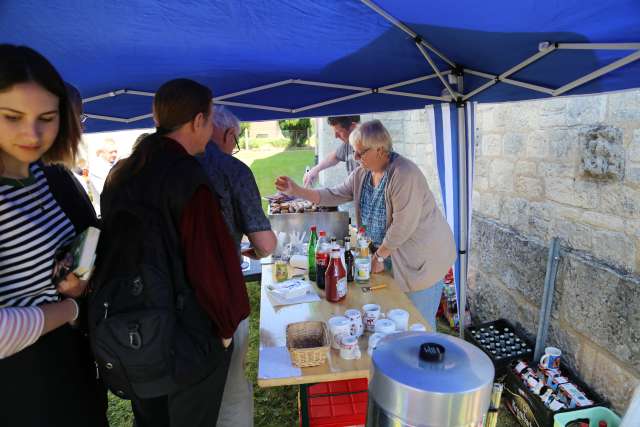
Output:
[580, 126, 625, 181]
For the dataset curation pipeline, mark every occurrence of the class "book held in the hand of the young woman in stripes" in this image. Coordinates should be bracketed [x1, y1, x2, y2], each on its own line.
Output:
[53, 227, 100, 285]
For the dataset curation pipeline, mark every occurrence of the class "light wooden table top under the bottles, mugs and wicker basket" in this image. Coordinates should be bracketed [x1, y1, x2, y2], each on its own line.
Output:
[258, 265, 430, 387]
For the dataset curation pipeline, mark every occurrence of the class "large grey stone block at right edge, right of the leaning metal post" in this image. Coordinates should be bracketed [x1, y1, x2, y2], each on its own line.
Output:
[556, 254, 640, 370]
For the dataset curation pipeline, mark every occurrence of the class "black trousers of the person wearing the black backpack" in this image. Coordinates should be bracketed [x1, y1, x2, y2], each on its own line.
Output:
[131, 346, 233, 427]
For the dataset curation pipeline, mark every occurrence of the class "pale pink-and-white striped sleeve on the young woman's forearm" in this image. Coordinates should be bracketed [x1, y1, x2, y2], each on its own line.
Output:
[0, 307, 44, 359]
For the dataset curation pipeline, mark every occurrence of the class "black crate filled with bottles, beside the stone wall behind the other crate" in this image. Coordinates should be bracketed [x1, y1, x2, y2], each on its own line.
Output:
[464, 319, 533, 378]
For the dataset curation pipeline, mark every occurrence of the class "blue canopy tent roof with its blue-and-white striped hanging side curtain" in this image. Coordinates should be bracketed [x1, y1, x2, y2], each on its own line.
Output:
[0, 0, 640, 342]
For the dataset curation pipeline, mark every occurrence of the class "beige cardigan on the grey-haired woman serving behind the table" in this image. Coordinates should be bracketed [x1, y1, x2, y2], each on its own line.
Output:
[319, 155, 456, 292]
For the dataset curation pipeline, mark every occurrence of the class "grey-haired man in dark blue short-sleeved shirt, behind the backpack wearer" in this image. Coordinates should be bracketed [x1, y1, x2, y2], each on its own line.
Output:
[199, 106, 276, 427]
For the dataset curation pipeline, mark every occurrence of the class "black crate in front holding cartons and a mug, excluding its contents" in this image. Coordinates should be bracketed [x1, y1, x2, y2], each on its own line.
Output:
[502, 363, 608, 427]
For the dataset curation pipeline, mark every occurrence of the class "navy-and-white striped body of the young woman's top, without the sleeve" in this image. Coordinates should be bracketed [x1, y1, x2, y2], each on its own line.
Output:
[0, 163, 75, 308]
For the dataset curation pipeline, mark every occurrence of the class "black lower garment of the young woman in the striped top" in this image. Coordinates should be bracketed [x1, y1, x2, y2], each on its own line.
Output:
[0, 325, 108, 427]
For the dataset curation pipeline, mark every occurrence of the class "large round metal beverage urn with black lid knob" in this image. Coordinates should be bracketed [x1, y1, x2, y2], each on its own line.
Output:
[367, 332, 495, 427]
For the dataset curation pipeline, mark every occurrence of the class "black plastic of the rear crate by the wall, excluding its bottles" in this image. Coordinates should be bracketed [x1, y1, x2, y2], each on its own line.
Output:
[464, 319, 533, 378]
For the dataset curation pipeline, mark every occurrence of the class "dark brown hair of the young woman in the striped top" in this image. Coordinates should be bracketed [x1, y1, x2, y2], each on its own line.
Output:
[0, 44, 81, 167]
